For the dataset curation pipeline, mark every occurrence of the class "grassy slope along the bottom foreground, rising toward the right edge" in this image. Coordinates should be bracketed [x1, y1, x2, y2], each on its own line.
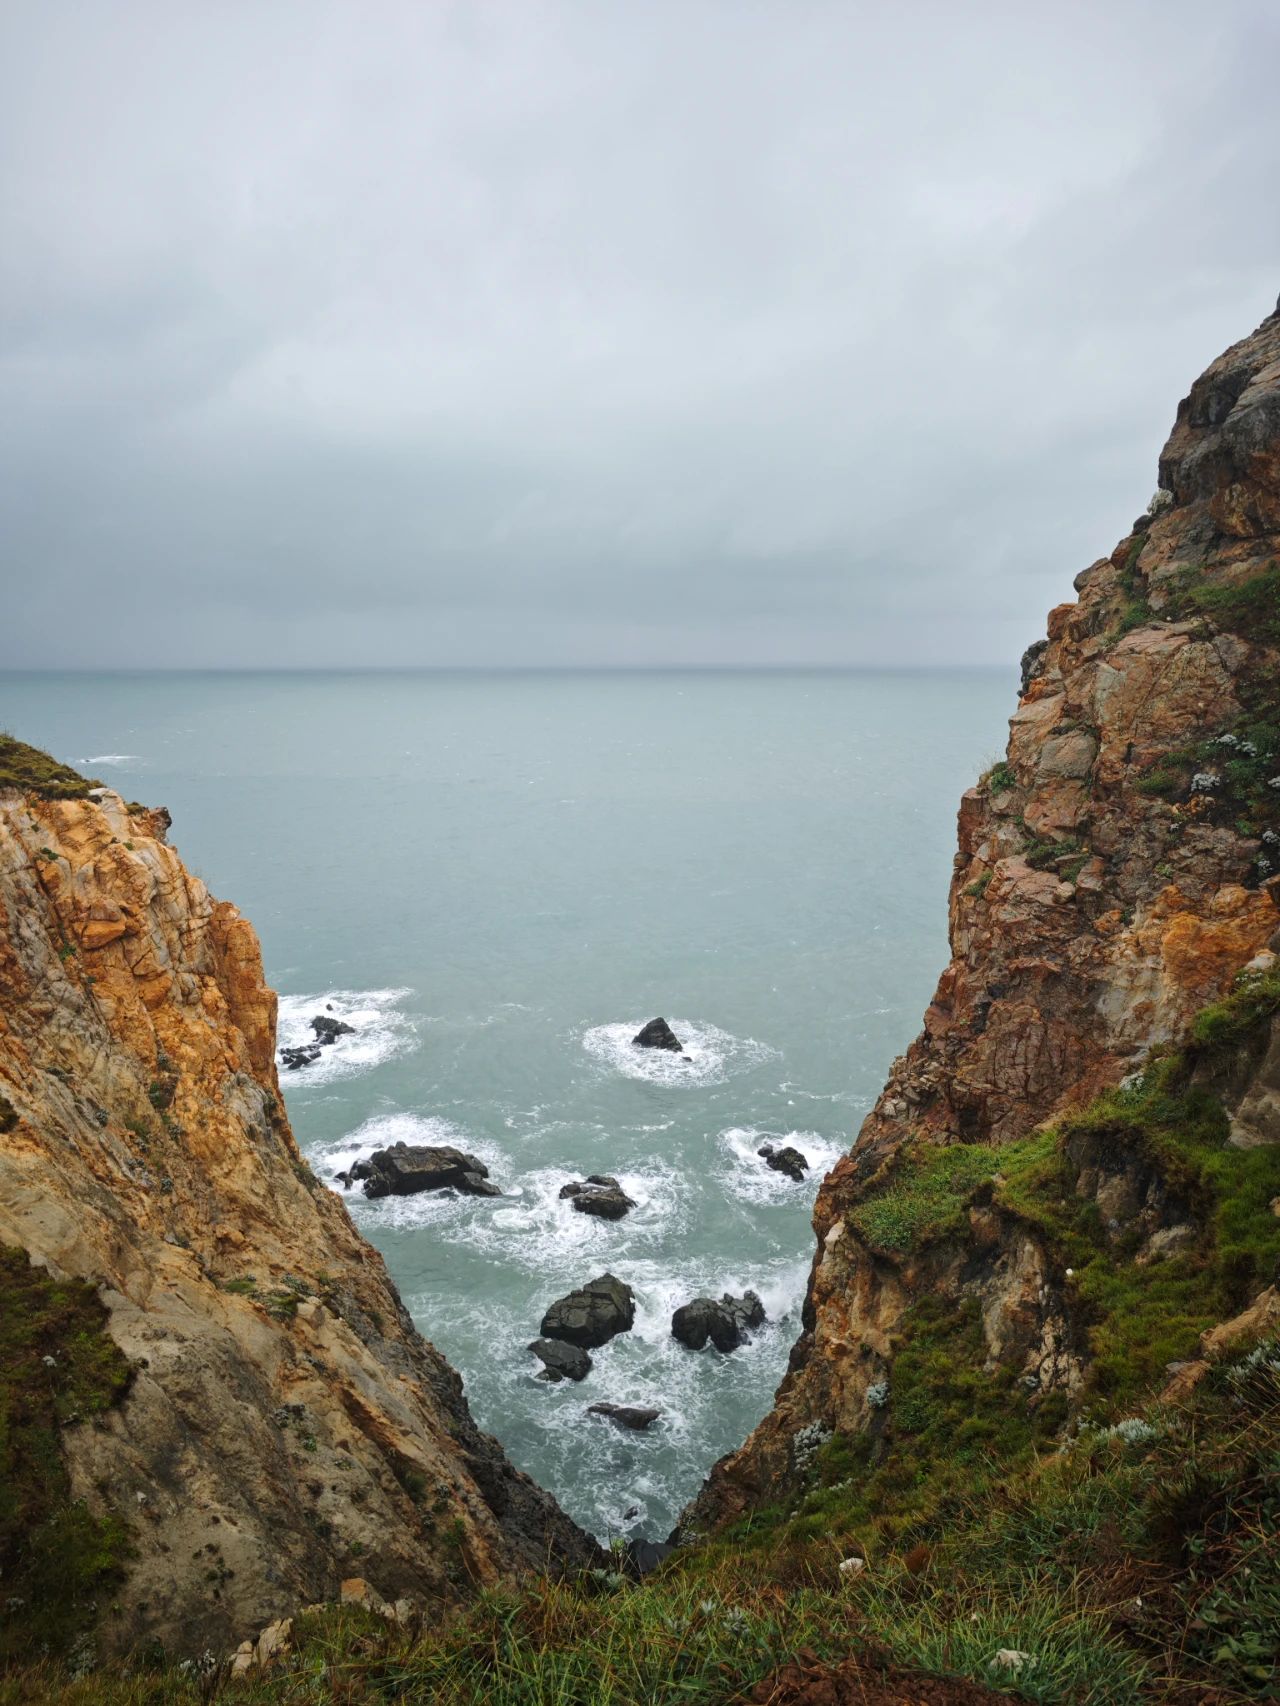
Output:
[15, 1344, 1280, 1706]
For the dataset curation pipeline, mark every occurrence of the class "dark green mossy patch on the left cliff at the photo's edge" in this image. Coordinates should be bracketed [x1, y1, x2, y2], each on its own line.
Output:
[0, 1245, 131, 1663]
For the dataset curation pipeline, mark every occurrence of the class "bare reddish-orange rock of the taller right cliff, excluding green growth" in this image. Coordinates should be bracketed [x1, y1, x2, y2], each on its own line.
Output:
[686, 303, 1280, 1530]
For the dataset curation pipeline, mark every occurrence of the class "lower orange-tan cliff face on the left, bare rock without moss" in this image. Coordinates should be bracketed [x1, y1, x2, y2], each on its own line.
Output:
[0, 778, 594, 1651]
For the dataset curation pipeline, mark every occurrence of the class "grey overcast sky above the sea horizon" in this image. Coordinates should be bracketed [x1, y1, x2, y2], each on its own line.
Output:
[0, 0, 1280, 667]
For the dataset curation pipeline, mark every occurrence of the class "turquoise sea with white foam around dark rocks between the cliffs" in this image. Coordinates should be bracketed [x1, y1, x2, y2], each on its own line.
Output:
[0, 672, 1014, 1537]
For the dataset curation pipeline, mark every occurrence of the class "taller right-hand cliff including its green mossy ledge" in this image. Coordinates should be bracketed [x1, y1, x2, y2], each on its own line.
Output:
[684, 303, 1280, 1532]
